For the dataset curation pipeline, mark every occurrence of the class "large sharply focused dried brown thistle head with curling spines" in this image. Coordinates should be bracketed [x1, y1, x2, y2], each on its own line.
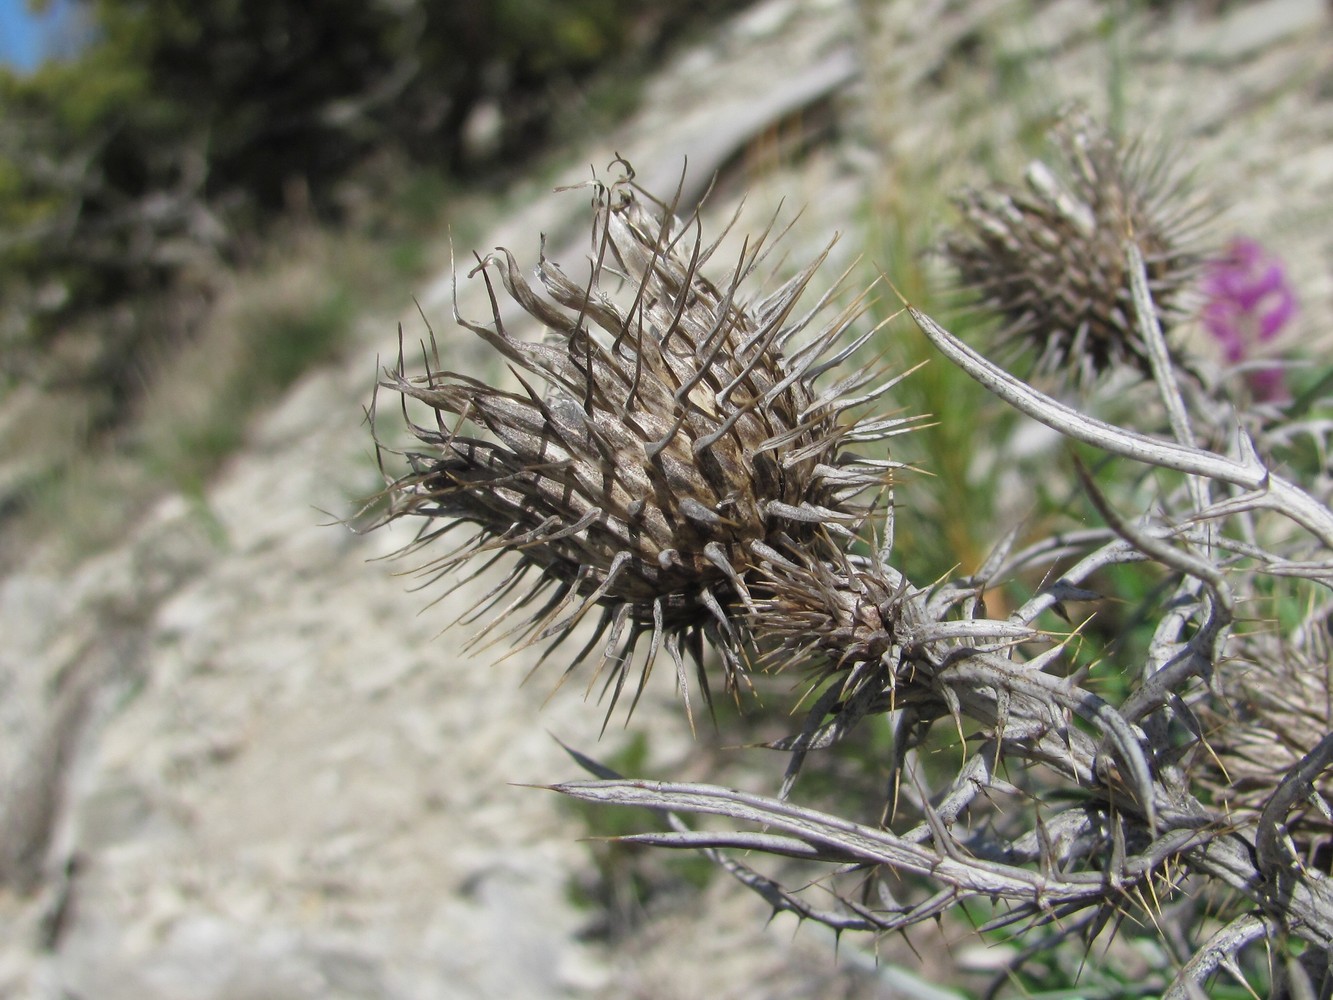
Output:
[365, 168, 908, 715]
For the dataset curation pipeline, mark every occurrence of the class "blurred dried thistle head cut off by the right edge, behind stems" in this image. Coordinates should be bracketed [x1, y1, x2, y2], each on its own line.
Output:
[1200, 619, 1333, 872]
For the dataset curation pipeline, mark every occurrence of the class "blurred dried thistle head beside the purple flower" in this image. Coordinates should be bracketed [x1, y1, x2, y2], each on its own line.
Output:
[944, 113, 1205, 383]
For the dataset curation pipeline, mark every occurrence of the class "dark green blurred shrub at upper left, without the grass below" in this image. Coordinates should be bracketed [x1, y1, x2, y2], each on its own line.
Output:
[0, 0, 738, 428]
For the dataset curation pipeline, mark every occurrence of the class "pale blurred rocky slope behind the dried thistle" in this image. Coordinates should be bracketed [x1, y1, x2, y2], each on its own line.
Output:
[0, 0, 1333, 1000]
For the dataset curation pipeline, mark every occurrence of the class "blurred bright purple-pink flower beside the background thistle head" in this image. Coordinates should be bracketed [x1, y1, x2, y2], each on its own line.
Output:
[1202, 236, 1296, 403]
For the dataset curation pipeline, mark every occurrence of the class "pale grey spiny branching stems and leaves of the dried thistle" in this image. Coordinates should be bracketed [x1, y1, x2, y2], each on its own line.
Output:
[555, 285, 1333, 997]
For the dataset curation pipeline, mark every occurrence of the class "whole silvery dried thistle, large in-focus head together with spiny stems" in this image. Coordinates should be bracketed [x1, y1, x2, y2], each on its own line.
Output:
[367, 149, 1333, 997]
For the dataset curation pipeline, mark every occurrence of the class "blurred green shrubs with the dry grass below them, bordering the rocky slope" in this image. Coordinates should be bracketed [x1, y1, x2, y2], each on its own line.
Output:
[0, 0, 740, 570]
